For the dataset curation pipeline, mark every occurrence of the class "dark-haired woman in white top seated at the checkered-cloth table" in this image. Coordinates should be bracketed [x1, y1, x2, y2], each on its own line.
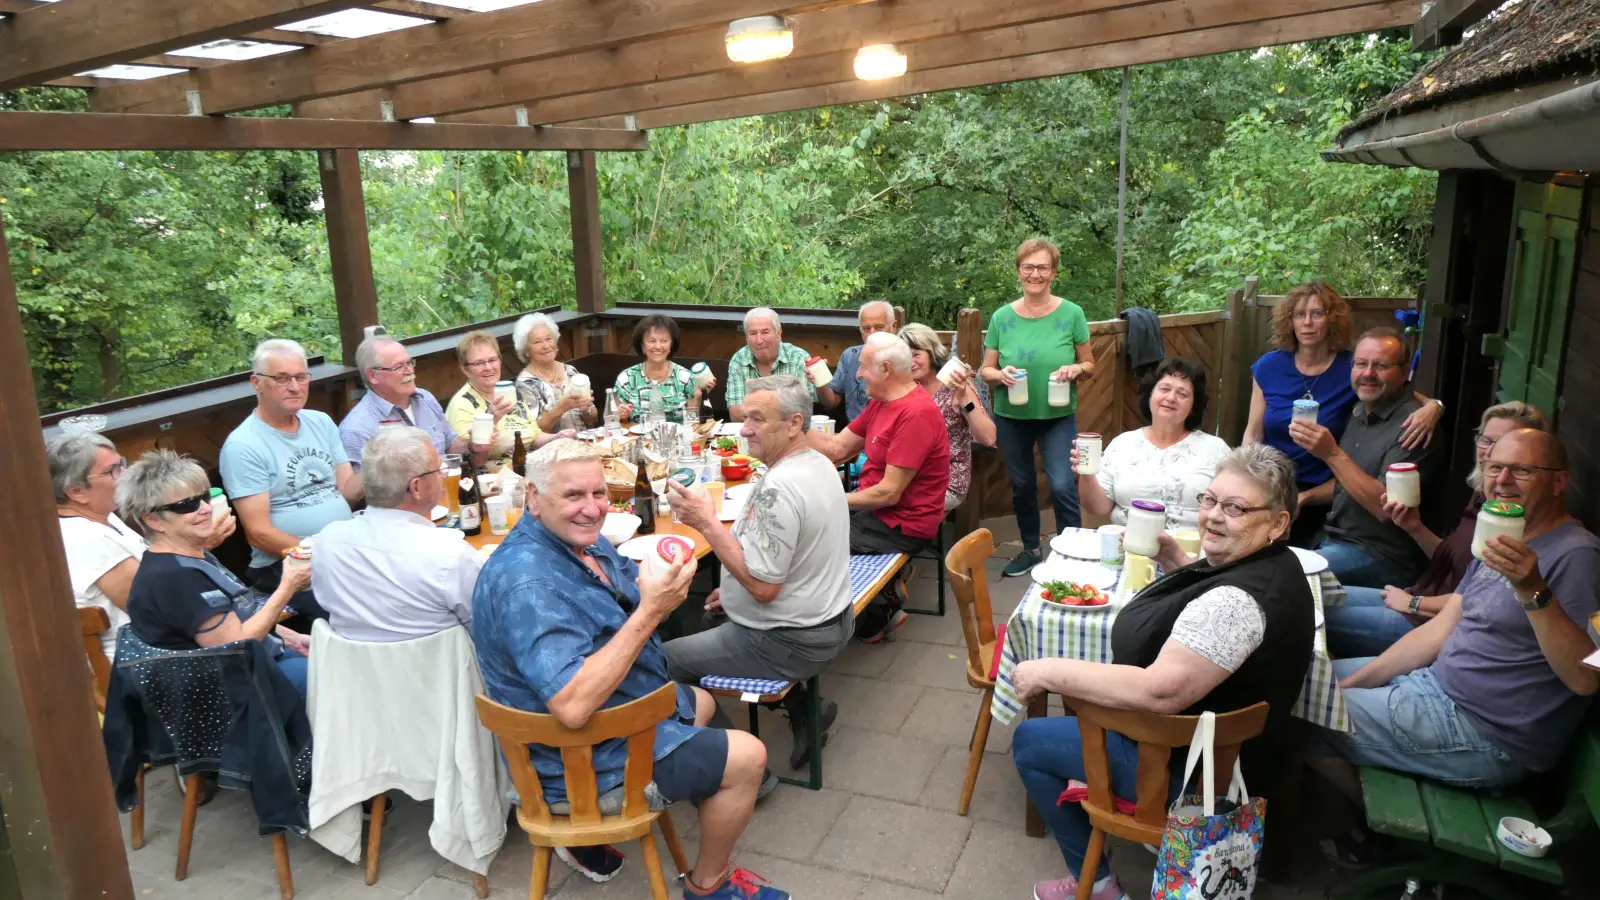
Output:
[1072, 357, 1227, 530]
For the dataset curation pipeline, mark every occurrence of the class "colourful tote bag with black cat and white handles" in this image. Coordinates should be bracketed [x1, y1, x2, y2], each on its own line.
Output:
[1150, 713, 1267, 900]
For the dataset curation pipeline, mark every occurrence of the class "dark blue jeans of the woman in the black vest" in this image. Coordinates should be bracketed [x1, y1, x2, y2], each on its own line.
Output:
[1011, 716, 1179, 881]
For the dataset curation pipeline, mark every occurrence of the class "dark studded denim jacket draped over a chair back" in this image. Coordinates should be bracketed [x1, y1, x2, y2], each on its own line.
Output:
[101, 626, 310, 834]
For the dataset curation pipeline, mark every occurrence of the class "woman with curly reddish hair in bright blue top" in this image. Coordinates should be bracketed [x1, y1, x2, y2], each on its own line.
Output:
[1243, 282, 1445, 548]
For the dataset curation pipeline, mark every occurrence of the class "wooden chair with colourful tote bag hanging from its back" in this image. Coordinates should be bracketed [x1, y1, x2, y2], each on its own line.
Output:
[1061, 697, 1267, 900]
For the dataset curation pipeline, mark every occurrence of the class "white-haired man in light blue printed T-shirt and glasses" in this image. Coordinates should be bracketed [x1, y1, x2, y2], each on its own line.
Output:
[219, 340, 362, 617]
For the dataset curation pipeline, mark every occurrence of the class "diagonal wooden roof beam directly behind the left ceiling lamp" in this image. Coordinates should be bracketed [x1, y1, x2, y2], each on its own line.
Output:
[296, 0, 1146, 119]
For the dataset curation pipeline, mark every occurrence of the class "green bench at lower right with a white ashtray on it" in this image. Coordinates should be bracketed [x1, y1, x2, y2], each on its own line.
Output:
[1338, 727, 1600, 900]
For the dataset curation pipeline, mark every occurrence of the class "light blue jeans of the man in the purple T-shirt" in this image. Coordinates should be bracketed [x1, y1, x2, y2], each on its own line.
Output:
[1312, 657, 1528, 788]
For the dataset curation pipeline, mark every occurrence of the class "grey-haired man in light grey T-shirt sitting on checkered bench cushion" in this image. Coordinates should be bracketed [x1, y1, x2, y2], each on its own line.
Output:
[666, 375, 856, 769]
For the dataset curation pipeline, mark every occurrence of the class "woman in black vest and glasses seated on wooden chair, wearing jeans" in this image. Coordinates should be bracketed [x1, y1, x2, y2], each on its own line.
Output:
[1011, 444, 1315, 900]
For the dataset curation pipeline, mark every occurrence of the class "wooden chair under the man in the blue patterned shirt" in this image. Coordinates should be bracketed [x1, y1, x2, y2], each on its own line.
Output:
[477, 682, 690, 900]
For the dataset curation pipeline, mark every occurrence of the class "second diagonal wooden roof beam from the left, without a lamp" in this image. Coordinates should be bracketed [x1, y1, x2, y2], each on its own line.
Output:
[91, 0, 862, 114]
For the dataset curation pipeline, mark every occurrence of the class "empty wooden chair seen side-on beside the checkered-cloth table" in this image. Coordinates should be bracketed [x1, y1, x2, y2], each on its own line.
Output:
[944, 528, 1005, 815]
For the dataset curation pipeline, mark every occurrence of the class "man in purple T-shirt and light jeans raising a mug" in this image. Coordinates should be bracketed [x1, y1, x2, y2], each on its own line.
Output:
[1314, 429, 1600, 798]
